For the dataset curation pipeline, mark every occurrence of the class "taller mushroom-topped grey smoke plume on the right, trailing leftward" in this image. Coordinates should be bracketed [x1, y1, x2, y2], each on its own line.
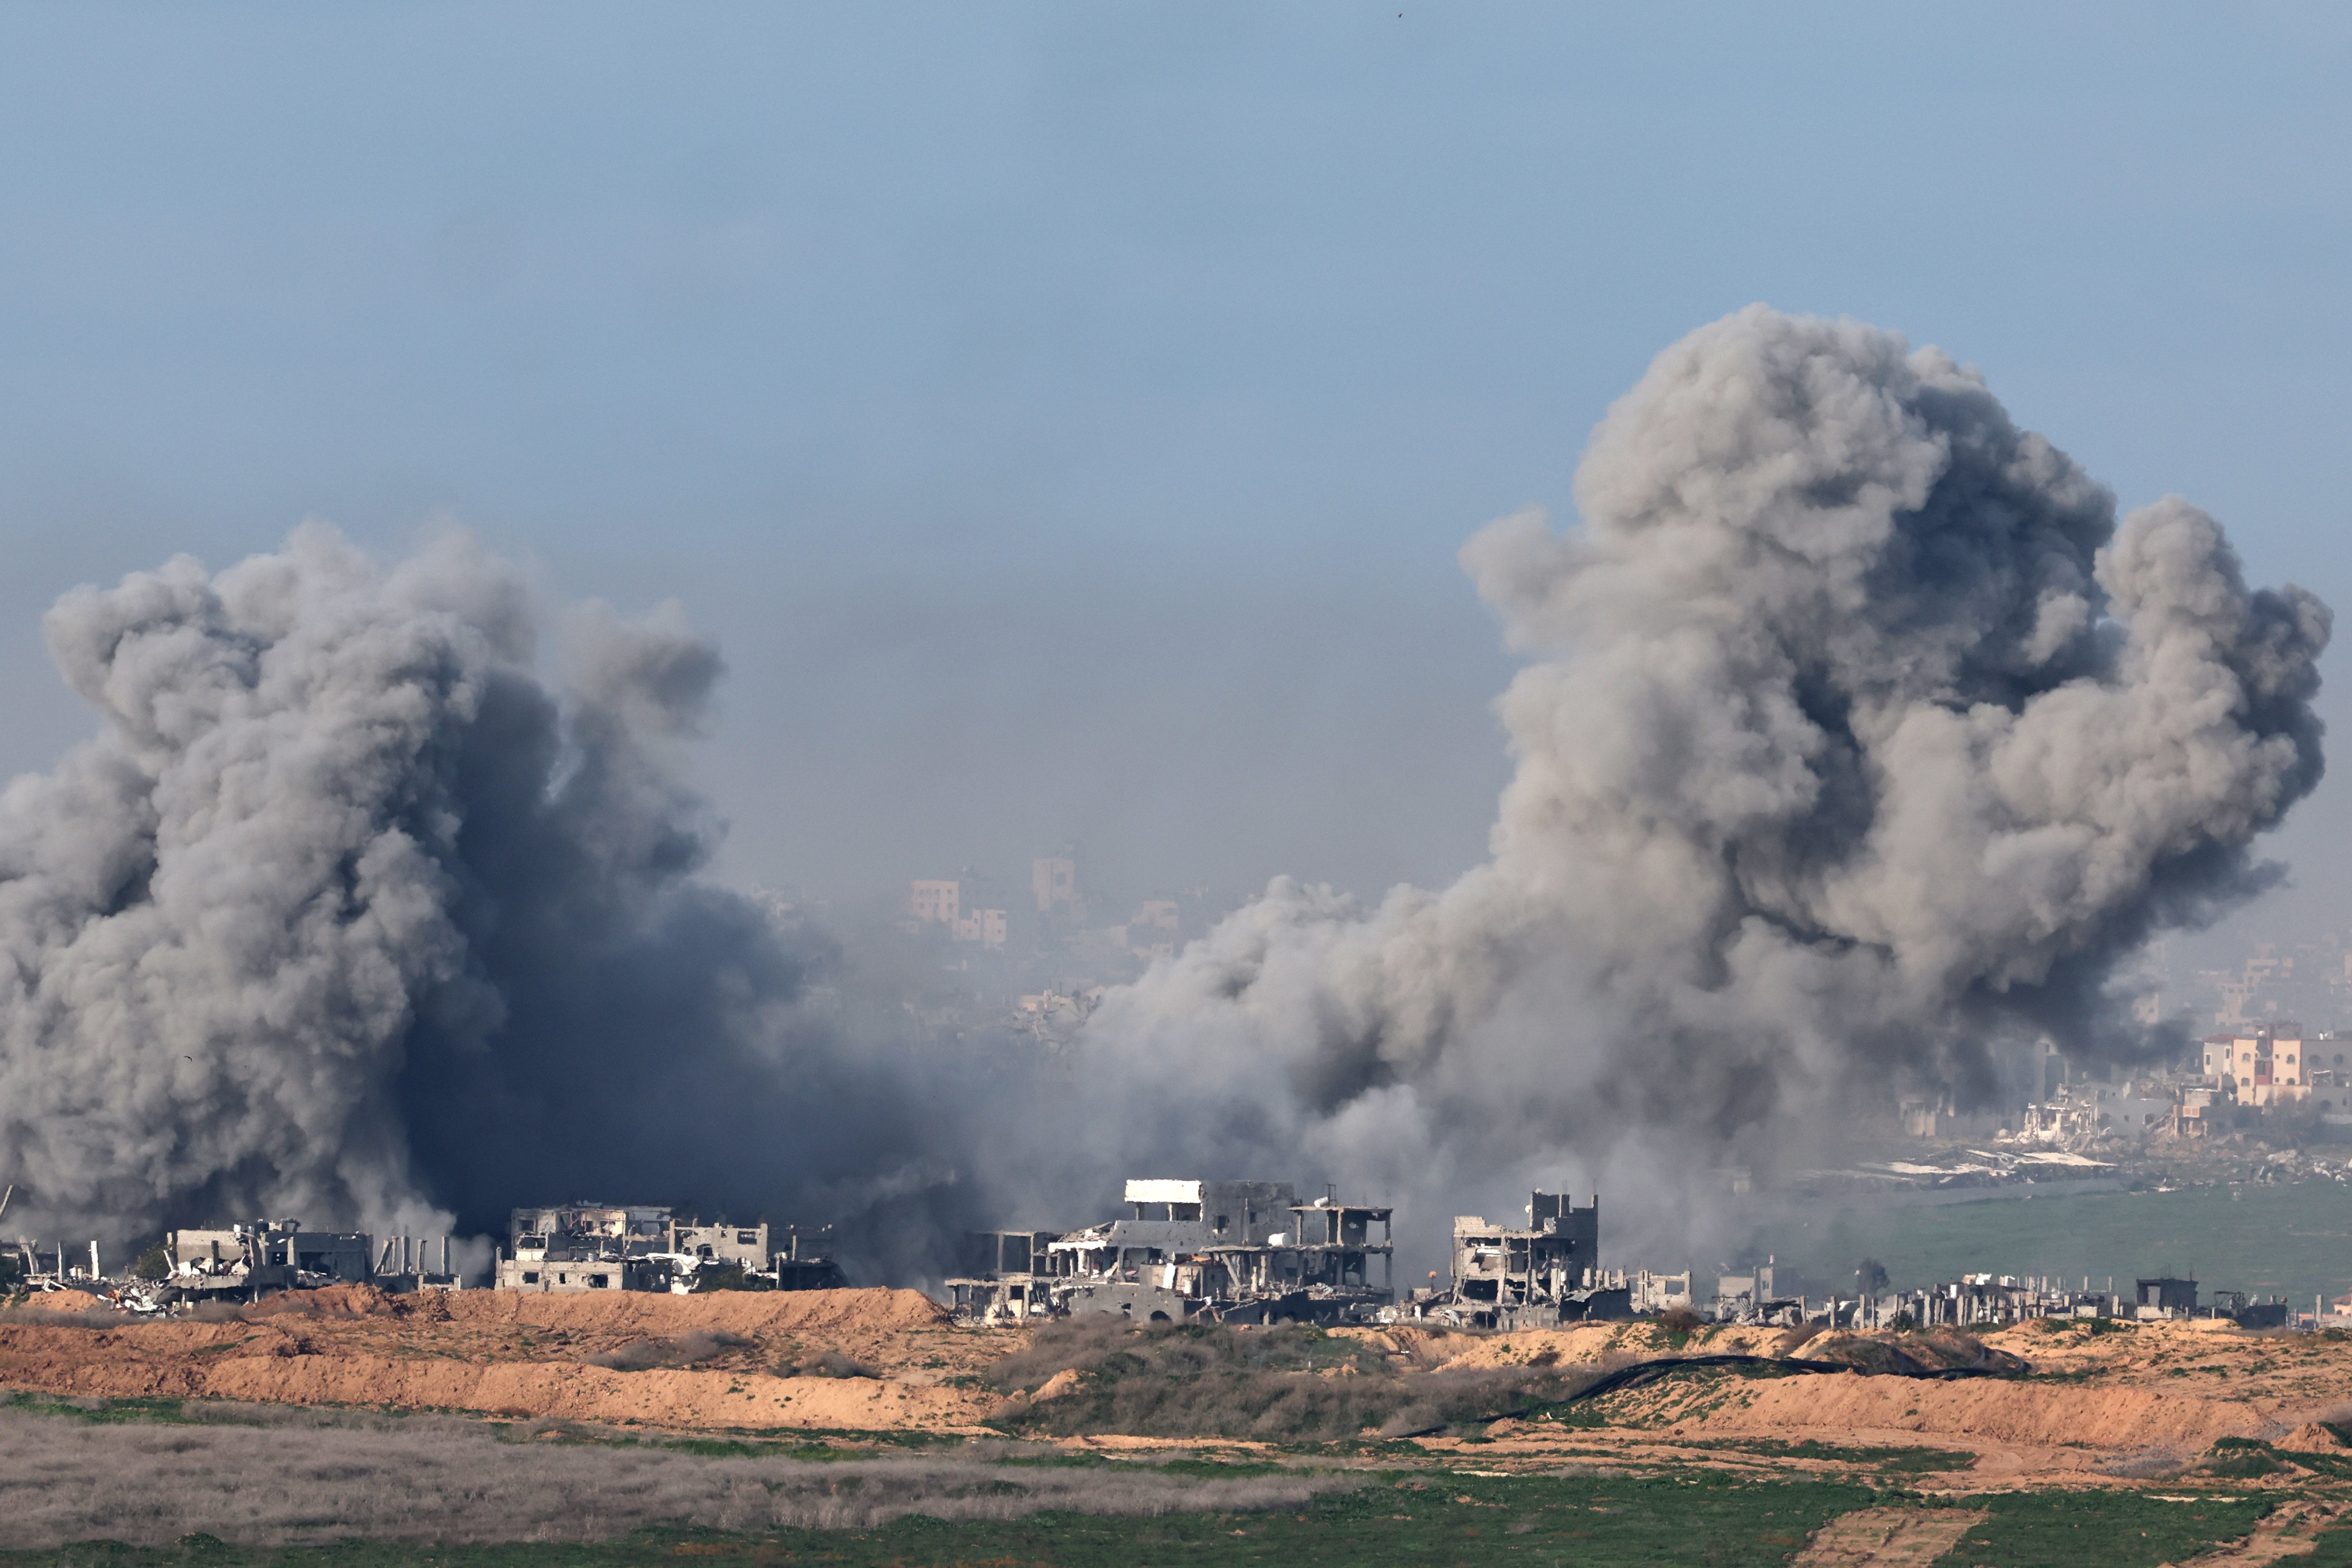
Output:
[1068, 306, 2328, 1218]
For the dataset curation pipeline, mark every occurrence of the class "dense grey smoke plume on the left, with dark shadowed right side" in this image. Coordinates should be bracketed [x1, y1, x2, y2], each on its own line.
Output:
[0, 526, 936, 1236]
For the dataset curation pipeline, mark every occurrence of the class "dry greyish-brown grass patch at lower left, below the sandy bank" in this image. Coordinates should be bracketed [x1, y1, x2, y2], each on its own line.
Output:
[0, 1406, 1359, 1549]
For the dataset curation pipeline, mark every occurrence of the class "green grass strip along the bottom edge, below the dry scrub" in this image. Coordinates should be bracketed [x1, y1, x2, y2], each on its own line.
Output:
[0, 1472, 2286, 1568]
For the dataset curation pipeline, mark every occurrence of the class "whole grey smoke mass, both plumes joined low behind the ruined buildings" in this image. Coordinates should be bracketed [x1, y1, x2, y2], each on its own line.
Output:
[0, 308, 2328, 1250]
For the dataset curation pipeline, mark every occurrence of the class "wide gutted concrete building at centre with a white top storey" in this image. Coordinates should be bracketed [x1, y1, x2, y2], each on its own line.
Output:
[948, 1178, 1395, 1323]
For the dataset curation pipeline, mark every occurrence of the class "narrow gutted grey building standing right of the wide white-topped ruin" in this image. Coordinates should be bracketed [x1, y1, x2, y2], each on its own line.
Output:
[1423, 1192, 1618, 1328]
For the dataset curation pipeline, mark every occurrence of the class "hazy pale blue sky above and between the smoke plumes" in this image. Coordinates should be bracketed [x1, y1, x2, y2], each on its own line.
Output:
[0, 0, 2352, 945]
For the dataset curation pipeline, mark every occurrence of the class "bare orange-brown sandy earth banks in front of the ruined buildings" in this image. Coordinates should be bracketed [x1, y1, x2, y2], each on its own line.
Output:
[0, 1288, 2352, 1490]
